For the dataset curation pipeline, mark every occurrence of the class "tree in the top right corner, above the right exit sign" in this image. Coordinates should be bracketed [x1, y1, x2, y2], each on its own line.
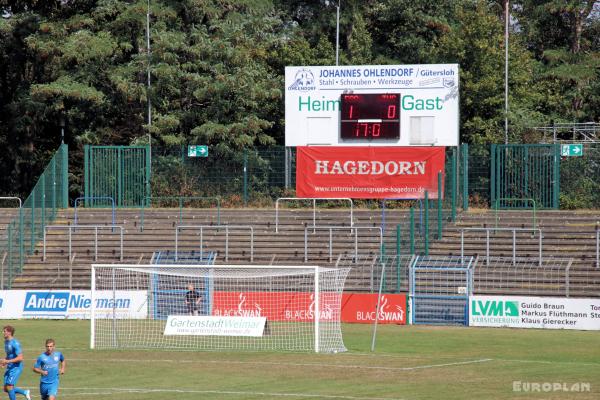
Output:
[516, 0, 600, 122]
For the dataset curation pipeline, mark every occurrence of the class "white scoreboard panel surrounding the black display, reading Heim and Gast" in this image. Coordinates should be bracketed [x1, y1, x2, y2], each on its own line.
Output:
[285, 64, 459, 147]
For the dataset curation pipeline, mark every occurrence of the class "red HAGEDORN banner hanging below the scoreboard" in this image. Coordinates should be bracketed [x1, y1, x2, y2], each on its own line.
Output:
[296, 146, 446, 199]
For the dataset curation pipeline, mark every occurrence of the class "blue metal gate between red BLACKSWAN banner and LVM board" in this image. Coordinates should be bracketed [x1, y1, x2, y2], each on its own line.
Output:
[409, 256, 476, 325]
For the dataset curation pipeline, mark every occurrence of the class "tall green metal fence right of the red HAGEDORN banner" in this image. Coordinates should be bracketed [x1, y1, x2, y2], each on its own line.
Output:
[466, 142, 600, 209]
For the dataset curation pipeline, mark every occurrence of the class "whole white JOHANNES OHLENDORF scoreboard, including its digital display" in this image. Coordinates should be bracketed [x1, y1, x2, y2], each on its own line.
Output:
[285, 64, 459, 146]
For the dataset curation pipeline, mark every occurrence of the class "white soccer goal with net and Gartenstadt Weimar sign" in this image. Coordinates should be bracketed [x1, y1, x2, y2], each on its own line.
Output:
[90, 264, 350, 353]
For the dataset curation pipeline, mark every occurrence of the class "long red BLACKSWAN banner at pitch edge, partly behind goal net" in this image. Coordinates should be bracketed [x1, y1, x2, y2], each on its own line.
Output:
[207, 292, 406, 324]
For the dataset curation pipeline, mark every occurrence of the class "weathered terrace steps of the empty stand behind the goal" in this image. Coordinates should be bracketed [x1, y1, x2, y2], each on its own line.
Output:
[1, 208, 600, 296]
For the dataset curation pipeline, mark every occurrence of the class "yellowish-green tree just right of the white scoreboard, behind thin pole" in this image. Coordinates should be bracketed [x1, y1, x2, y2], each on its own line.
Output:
[435, 0, 541, 143]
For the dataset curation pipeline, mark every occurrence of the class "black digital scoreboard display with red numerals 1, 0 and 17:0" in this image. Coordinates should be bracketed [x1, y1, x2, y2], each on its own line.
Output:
[340, 93, 400, 140]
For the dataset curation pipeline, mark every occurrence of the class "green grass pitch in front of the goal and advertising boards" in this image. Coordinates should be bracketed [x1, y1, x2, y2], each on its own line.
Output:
[0, 320, 600, 400]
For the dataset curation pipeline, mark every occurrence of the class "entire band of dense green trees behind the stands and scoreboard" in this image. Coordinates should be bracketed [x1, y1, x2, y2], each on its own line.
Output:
[0, 0, 600, 206]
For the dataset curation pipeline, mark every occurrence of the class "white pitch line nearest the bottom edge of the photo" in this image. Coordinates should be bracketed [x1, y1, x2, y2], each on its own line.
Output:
[60, 387, 405, 400]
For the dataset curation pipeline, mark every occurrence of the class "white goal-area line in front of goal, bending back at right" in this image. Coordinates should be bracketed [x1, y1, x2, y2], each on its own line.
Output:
[62, 358, 493, 371]
